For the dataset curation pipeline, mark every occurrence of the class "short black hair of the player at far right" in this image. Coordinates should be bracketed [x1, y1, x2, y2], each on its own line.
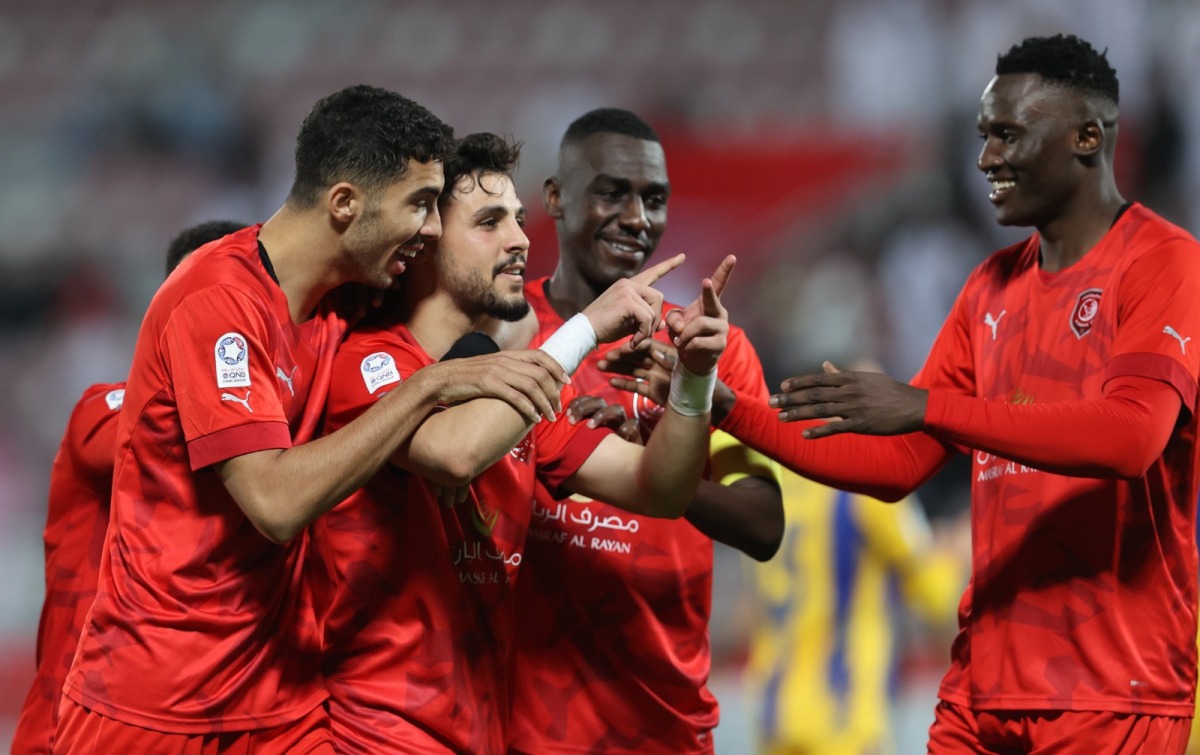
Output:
[996, 34, 1121, 104]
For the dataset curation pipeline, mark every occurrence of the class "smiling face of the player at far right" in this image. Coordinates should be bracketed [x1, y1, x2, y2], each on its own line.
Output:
[978, 73, 1088, 228]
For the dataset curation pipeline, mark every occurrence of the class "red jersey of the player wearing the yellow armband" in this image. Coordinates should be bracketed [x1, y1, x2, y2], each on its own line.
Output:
[512, 278, 768, 753]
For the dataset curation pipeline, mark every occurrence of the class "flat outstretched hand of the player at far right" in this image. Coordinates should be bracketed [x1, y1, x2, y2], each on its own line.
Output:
[770, 362, 929, 438]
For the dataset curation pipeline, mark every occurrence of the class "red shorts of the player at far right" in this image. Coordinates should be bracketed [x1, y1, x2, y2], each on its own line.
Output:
[929, 700, 1192, 755]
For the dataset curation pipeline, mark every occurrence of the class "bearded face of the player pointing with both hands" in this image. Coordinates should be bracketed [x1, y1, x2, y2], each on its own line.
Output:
[434, 173, 529, 322]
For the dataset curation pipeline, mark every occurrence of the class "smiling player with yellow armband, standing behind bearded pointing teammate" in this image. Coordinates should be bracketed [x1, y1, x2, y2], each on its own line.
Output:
[512, 108, 782, 754]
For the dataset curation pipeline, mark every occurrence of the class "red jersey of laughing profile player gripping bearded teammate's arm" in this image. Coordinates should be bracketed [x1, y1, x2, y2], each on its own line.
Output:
[64, 227, 344, 733]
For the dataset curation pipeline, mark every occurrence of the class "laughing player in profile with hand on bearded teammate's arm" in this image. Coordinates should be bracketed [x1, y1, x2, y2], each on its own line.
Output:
[55, 85, 562, 753]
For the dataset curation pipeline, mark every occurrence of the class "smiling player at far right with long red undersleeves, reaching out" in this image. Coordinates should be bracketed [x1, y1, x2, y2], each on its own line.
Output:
[722, 35, 1200, 754]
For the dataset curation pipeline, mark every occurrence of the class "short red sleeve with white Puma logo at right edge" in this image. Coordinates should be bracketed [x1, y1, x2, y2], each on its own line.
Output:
[1104, 238, 1200, 412]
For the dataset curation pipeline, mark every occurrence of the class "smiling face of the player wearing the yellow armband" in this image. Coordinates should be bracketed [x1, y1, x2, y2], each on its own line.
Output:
[545, 133, 671, 293]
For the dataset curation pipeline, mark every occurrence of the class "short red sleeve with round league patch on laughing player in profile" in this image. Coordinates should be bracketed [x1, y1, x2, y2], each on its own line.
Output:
[162, 286, 292, 471]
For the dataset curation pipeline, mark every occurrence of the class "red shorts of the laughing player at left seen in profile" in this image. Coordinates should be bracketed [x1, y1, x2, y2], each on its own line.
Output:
[54, 695, 334, 755]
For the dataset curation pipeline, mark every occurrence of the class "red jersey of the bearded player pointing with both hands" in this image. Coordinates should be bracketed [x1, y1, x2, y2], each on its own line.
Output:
[313, 325, 610, 754]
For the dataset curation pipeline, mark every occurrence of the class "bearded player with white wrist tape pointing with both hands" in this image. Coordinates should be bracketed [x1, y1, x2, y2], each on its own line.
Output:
[313, 133, 728, 755]
